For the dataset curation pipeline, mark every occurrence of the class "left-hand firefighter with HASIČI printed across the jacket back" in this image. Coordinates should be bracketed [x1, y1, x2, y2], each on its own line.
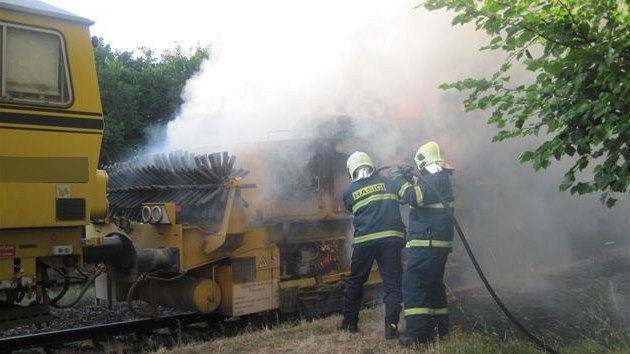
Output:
[338, 151, 405, 339]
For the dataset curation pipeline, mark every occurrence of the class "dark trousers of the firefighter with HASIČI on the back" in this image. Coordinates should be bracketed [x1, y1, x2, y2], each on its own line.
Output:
[343, 241, 403, 325]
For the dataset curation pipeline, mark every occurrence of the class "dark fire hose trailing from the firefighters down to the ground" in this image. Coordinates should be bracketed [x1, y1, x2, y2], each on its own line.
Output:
[390, 167, 559, 354]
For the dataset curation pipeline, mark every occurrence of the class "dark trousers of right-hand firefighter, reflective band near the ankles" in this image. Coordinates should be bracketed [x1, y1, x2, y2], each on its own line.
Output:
[402, 247, 450, 341]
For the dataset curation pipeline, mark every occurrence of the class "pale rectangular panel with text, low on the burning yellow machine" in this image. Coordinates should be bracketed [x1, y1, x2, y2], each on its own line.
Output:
[233, 279, 279, 316]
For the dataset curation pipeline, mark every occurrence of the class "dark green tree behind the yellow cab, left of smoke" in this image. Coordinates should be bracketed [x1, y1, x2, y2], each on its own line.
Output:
[93, 37, 208, 165]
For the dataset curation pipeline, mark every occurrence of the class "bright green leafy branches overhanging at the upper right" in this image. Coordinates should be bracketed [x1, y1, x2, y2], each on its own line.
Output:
[423, 0, 630, 207]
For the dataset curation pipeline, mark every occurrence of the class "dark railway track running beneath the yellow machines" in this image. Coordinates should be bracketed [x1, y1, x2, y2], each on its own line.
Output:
[0, 290, 377, 354]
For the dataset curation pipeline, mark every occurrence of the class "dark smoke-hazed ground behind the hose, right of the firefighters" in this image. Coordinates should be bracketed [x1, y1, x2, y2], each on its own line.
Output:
[449, 246, 630, 343]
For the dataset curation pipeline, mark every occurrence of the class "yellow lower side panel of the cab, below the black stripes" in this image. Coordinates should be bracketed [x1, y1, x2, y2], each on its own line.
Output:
[0, 130, 100, 228]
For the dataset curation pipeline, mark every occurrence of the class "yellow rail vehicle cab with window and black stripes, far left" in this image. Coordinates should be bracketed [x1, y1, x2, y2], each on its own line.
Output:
[0, 0, 107, 319]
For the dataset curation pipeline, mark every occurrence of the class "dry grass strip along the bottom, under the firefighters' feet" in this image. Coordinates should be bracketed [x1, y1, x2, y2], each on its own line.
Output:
[153, 306, 630, 354]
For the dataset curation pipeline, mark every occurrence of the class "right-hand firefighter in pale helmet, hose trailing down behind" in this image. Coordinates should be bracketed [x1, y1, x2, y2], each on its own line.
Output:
[395, 141, 454, 346]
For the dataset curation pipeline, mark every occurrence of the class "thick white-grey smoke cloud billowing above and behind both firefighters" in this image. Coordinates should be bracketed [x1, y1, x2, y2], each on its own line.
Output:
[167, 0, 630, 294]
